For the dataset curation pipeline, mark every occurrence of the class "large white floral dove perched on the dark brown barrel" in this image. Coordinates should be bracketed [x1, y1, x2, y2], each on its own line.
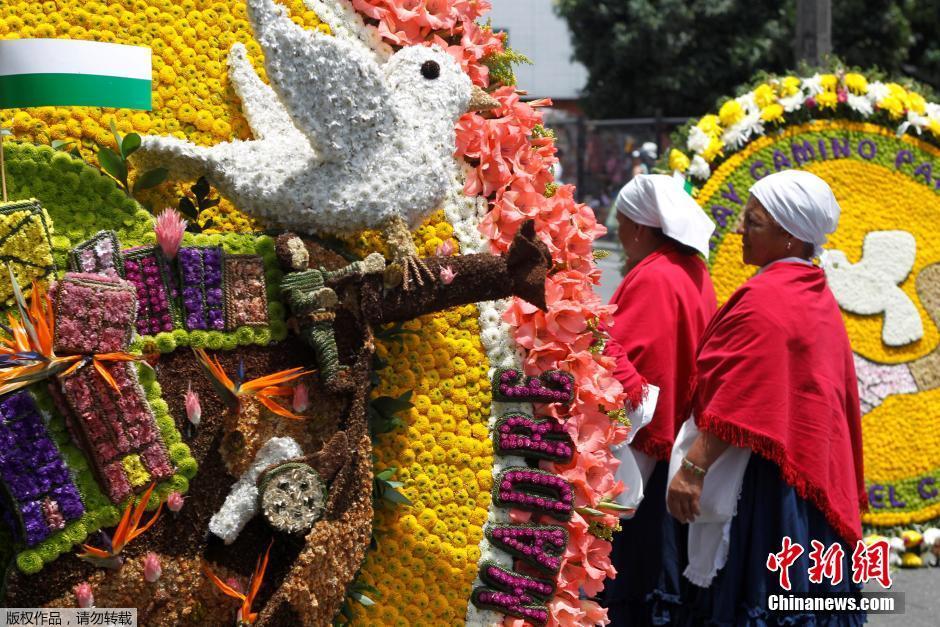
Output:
[139, 0, 499, 282]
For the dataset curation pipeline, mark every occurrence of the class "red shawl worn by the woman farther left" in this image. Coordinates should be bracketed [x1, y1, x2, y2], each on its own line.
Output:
[604, 244, 716, 460]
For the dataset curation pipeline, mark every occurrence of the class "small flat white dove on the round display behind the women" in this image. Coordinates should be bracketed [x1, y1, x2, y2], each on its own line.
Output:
[821, 231, 924, 346]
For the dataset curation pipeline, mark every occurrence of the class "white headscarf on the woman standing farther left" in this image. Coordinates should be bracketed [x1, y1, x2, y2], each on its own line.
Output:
[614, 174, 715, 259]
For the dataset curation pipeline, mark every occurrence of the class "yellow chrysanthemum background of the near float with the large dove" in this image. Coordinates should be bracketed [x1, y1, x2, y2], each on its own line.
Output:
[0, 0, 493, 625]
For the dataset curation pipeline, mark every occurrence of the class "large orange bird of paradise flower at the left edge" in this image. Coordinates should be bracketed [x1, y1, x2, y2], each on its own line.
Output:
[0, 266, 139, 395]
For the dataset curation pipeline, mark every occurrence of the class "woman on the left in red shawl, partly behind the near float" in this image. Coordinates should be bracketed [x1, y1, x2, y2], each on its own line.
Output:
[604, 175, 716, 625]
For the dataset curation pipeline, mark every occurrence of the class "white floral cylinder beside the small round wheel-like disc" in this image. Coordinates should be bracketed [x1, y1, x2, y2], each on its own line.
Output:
[209, 437, 303, 544]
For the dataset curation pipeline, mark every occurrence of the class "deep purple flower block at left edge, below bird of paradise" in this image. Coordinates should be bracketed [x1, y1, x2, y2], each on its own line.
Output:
[0, 391, 85, 546]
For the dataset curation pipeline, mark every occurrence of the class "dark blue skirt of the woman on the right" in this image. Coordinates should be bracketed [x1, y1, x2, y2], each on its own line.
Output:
[652, 454, 866, 627]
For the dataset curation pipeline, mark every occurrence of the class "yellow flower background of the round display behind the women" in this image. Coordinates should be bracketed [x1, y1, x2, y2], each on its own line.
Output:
[697, 121, 940, 526]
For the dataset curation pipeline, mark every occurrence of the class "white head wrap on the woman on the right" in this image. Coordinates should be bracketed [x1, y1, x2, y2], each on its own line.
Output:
[750, 170, 842, 257]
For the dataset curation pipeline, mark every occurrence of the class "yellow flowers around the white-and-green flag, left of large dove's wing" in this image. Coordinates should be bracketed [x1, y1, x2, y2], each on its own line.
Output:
[0, 0, 326, 231]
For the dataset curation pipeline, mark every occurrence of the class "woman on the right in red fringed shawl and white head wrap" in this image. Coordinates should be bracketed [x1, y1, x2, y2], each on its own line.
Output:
[667, 171, 866, 626]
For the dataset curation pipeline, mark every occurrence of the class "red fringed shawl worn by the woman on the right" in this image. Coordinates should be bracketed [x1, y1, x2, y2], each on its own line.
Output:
[693, 262, 867, 545]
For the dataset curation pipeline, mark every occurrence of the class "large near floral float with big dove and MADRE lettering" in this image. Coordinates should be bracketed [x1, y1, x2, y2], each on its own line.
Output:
[0, 0, 627, 625]
